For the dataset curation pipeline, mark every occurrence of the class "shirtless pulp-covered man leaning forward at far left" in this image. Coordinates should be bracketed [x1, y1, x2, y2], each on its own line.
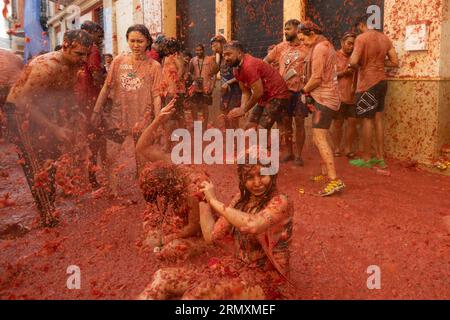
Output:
[5, 30, 93, 226]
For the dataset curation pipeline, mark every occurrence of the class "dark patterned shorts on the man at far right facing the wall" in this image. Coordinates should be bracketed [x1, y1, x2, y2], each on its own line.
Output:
[356, 81, 387, 119]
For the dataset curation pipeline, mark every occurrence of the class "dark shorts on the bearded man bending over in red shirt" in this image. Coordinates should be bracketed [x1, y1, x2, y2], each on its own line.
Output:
[249, 99, 289, 129]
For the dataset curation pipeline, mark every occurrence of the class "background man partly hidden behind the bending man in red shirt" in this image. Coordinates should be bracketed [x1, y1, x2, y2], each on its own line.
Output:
[211, 35, 242, 129]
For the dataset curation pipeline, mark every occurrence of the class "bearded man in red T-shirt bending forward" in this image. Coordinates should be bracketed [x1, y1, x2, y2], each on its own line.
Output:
[227, 41, 291, 130]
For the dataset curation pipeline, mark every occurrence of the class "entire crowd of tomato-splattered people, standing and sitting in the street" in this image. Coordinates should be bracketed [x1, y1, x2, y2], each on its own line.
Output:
[0, 16, 398, 299]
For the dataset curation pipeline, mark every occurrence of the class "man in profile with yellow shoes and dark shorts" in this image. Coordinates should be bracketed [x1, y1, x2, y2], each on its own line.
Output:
[299, 22, 345, 196]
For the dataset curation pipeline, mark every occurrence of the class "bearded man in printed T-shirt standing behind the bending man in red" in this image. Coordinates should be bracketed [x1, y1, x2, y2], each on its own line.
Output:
[264, 19, 309, 166]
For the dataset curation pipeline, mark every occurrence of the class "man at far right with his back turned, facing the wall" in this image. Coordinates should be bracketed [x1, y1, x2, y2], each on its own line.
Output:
[349, 15, 399, 168]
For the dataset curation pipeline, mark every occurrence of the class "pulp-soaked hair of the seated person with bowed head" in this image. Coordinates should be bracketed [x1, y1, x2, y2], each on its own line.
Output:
[139, 161, 187, 210]
